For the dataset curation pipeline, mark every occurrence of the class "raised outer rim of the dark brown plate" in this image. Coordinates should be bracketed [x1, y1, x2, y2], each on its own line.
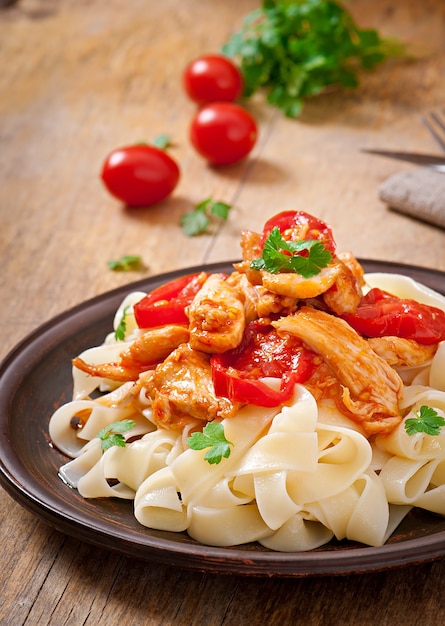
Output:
[0, 258, 445, 577]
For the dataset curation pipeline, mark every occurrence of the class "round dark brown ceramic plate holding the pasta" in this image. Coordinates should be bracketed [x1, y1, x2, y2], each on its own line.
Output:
[0, 261, 445, 577]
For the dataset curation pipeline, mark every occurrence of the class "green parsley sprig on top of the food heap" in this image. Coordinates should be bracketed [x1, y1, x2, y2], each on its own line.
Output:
[250, 226, 332, 278]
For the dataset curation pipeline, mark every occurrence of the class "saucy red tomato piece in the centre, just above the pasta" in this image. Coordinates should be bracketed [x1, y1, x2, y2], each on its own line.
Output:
[210, 322, 315, 407]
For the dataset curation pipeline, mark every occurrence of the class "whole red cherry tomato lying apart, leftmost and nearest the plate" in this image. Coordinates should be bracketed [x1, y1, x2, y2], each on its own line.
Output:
[101, 144, 180, 207]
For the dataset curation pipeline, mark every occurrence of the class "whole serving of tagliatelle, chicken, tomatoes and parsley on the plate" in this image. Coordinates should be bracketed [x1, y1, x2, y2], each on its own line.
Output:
[49, 211, 445, 552]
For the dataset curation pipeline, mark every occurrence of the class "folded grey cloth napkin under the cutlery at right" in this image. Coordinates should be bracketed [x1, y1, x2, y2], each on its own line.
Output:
[379, 167, 445, 228]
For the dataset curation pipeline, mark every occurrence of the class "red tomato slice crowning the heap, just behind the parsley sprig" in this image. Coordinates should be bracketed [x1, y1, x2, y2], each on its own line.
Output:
[261, 211, 336, 254]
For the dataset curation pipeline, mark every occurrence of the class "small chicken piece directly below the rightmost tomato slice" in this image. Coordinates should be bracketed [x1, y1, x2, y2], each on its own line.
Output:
[368, 337, 437, 367]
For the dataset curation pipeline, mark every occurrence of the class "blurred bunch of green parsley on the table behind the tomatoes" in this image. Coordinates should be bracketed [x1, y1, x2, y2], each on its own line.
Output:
[222, 0, 405, 117]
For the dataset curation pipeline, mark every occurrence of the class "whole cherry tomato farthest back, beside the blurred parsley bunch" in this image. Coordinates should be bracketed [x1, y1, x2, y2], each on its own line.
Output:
[183, 54, 243, 104]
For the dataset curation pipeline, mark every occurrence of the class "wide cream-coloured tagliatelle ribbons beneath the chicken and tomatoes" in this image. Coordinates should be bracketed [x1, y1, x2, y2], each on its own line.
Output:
[49, 211, 445, 552]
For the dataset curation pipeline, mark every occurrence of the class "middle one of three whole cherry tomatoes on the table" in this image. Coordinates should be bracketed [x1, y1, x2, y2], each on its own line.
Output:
[190, 102, 258, 165]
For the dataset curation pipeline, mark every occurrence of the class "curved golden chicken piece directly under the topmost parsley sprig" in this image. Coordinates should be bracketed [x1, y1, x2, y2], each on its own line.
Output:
[261, 261, 342, 300]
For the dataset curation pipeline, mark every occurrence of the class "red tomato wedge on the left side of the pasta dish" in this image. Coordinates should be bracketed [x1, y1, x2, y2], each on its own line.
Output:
[134, 272, 207, 328]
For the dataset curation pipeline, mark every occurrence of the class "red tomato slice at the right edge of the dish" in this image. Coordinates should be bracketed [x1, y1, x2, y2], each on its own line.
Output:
[342, 288, 445, 345]
